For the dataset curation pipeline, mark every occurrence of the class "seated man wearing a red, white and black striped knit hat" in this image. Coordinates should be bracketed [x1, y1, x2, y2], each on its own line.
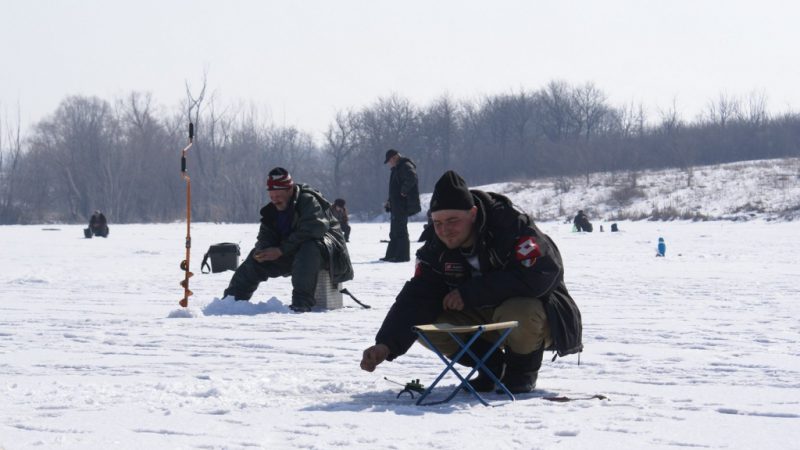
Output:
[224, 167, 353, 312]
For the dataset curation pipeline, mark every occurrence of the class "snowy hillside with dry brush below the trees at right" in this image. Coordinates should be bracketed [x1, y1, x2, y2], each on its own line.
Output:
[418, 158, 800, 221]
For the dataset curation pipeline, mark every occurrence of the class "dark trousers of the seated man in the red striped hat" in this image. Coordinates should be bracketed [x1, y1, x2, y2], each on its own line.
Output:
[224, 241, 326, 307]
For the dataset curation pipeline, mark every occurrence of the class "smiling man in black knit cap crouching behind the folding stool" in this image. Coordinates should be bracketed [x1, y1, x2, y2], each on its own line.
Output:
[361, 171, 583, 393]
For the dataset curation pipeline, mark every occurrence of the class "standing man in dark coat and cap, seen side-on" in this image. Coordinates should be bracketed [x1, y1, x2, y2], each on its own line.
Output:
[381, 148, 422, 262]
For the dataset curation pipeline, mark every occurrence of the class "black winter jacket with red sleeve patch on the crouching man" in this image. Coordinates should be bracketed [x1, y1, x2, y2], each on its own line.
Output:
[375, 190, 583, 360]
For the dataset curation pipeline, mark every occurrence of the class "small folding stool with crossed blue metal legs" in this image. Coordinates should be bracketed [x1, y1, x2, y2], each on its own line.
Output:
[413, 321, 519, 406]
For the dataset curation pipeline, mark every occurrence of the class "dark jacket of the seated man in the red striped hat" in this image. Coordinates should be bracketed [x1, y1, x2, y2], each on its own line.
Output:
[256, 184, 353, 283]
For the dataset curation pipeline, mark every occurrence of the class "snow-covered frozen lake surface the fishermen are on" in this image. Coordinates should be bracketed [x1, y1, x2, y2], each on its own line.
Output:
[0, 220, 800, 450]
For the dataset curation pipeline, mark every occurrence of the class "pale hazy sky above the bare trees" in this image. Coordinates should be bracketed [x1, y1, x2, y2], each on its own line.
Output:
[0, 0, 800, 137]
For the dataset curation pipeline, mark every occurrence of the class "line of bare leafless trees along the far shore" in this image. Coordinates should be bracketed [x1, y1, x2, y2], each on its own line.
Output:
[0, 81, 800, 224]
